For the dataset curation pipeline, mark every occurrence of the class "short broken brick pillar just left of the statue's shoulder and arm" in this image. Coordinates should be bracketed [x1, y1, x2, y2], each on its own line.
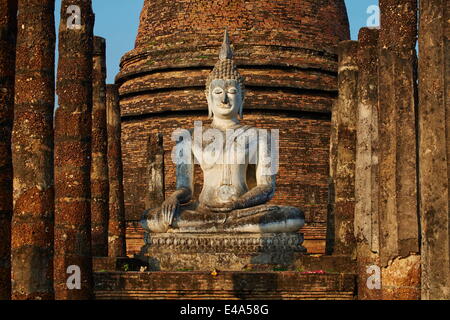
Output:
[145, 133, 164, 209]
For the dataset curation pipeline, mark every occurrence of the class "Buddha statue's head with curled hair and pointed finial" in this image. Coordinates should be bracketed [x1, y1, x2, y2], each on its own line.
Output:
[206, 30, 245, 119]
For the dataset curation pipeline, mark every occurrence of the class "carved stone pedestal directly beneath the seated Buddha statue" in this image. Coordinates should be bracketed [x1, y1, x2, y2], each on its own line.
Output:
[138, 233, 306, 271]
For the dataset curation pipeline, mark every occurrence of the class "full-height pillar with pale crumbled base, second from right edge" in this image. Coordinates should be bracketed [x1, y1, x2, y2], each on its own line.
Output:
[378, 0, 420, 299]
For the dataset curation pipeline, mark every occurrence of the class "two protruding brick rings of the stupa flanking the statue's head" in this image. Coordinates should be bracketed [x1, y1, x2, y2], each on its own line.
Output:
[120, 69, 337, 116]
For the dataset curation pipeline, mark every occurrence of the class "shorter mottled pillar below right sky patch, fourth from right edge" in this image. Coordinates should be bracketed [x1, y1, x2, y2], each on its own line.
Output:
[333, 41, 358, 256]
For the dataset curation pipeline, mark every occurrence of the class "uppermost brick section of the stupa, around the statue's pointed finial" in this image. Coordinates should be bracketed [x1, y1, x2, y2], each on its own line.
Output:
[119, 0, 349, 87]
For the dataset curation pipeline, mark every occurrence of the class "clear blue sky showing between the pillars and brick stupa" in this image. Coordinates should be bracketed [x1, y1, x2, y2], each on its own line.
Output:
[55, 0, 378, 83]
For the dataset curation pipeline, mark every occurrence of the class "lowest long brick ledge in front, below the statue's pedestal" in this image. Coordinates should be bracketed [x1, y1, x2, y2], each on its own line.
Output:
[94, 271, 355, 302]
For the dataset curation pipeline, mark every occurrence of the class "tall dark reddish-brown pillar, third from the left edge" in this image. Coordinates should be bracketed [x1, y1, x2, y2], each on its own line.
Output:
[54, 0, 94, 300]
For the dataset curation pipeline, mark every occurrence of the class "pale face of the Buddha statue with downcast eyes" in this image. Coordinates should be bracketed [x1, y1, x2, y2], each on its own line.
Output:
[208, 80, 243, 119]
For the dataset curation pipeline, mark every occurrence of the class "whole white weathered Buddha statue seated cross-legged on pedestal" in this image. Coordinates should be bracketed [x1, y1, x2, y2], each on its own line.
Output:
[141, 31, 304, 233]
